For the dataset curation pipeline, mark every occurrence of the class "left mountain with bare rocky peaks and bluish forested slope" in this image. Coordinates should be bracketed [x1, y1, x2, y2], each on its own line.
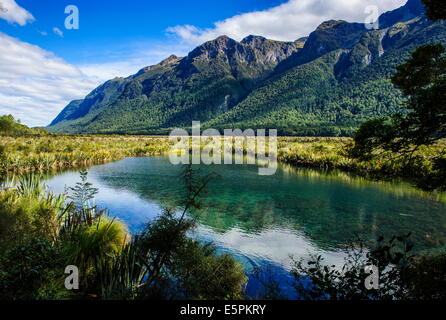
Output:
[49, 36, 304, 133]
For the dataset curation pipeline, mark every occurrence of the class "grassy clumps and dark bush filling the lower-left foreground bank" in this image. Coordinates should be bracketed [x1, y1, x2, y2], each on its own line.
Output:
[0, 170, 246, 300]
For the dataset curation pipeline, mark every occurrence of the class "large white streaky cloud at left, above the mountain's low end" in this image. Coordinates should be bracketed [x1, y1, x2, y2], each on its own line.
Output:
[0, 32, 188, 126]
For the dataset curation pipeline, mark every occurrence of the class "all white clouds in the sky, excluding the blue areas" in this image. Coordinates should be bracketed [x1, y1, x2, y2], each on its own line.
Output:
[0, 0, 412, 126]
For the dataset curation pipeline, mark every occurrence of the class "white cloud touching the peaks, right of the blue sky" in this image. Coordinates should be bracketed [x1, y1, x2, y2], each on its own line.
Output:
[167, 0, 407, 45]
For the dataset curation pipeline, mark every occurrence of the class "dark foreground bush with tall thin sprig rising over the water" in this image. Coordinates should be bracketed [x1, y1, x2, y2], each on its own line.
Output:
[96, 166, 247, 300]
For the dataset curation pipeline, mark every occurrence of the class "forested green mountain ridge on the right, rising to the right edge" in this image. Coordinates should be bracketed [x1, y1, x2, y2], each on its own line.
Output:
[205, 10, 446, 135]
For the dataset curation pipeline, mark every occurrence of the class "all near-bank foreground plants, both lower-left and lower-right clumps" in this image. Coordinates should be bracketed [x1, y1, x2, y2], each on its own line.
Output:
[0, 171, 446, 300]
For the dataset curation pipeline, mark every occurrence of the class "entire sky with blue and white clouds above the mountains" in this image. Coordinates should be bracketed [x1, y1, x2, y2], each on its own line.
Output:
[0, 0, 406, 126]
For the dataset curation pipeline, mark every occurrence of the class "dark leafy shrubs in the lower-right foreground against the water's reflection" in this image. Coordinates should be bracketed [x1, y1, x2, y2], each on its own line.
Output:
[254, 234, 446, 301]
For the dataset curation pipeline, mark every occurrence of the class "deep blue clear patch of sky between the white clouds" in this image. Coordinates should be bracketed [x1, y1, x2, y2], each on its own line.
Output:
[0, 0, 286, 67]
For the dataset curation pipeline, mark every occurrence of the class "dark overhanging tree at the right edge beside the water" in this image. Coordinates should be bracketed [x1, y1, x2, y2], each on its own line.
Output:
[350, 0, 446, 189]
